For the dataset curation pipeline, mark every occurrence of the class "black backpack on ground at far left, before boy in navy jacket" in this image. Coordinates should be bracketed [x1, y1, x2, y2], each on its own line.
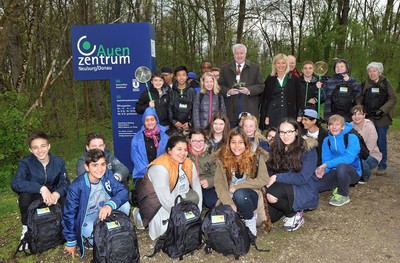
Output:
[14, 198, 64, 256]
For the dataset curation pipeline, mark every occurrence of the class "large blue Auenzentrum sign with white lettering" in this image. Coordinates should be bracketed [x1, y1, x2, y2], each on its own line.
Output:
[71, 23, 156, 171]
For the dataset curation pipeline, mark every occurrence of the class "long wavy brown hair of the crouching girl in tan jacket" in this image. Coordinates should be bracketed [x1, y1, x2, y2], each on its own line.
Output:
[220, 127, 257, 184]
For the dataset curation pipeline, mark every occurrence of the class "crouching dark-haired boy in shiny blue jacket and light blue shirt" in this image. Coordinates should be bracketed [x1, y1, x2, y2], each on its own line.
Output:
[62, 149, 130, 258]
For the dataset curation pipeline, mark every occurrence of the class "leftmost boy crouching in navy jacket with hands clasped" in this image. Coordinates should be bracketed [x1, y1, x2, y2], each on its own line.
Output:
[11, 132, 70, 249]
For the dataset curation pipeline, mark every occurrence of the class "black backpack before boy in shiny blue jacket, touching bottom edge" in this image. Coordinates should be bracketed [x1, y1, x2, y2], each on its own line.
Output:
[92, 210, 140, 263]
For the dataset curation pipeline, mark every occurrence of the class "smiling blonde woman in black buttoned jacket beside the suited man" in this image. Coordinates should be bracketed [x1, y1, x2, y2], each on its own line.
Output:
[259, 54, 303, 130]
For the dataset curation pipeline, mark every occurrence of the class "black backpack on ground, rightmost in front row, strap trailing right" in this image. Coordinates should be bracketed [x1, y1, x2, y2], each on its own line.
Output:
[201, 205, 269, 259]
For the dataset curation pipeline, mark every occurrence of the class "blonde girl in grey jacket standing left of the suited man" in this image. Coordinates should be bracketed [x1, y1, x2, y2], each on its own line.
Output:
[193, 72, 226, 129]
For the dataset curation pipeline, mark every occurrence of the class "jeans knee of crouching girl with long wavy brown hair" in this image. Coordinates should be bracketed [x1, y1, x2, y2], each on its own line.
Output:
[232, 188, 258, 219]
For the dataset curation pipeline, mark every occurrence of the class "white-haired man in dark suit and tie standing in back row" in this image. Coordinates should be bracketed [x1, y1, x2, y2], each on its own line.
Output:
[218, 44, 264, 127]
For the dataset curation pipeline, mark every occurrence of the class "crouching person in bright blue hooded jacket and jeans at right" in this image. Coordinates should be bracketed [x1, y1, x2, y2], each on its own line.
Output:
[315, 115, 362, 206]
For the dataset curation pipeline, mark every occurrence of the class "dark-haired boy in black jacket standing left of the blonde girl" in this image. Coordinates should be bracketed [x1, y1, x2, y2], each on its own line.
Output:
[168, 66, 196, 134]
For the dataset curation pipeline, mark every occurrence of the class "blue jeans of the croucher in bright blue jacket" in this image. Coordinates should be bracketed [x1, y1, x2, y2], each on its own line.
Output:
[318, 163, 360, 196]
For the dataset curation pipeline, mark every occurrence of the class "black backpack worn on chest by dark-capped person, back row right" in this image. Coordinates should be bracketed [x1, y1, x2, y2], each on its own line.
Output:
[331, 83, 355, 121]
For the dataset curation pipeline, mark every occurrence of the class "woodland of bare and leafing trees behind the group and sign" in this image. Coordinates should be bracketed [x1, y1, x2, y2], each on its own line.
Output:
[0, 0, 400, 191]
